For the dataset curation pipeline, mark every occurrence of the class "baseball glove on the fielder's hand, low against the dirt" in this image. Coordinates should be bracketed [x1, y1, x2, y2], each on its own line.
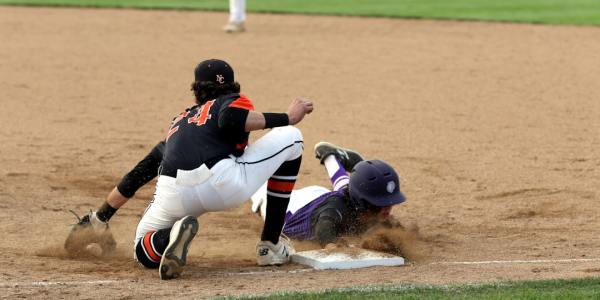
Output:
[65, 210, 117, 256]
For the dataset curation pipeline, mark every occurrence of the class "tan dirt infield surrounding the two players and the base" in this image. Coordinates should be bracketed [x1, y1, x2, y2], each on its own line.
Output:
[0, 7, 600, 299]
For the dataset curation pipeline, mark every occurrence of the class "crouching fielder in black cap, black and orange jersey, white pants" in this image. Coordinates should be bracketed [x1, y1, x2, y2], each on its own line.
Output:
[65, 59, 313, 279]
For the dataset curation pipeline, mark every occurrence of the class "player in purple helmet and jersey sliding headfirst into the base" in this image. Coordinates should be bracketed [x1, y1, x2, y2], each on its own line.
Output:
[252, 142, 405, 246]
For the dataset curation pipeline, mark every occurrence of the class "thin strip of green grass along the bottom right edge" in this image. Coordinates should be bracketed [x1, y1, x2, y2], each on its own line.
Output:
[231, 278, 600, 300]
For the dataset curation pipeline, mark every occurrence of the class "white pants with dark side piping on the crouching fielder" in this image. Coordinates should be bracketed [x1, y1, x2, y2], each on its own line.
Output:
[134, 126, 303, 245]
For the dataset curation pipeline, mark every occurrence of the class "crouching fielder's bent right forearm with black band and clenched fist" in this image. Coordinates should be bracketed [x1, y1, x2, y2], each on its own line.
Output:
[245, 97, 314, 132]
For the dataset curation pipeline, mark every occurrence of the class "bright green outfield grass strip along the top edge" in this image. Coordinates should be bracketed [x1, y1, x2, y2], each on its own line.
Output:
[0, 0, 600, 25]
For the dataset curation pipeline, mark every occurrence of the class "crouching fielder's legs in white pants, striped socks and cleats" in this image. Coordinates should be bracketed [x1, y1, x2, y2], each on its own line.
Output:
[136, 126, 303, 270]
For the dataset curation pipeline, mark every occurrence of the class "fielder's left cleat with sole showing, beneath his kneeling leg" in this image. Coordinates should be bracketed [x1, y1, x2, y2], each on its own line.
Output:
[159, 216, 198, 280]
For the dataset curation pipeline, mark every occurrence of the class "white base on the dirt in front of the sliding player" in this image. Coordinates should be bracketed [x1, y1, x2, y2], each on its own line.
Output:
[292, 248, 404, 270]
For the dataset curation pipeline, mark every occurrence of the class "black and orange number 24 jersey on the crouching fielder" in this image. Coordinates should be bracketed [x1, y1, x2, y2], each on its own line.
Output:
[161, 93, 254, 176]
